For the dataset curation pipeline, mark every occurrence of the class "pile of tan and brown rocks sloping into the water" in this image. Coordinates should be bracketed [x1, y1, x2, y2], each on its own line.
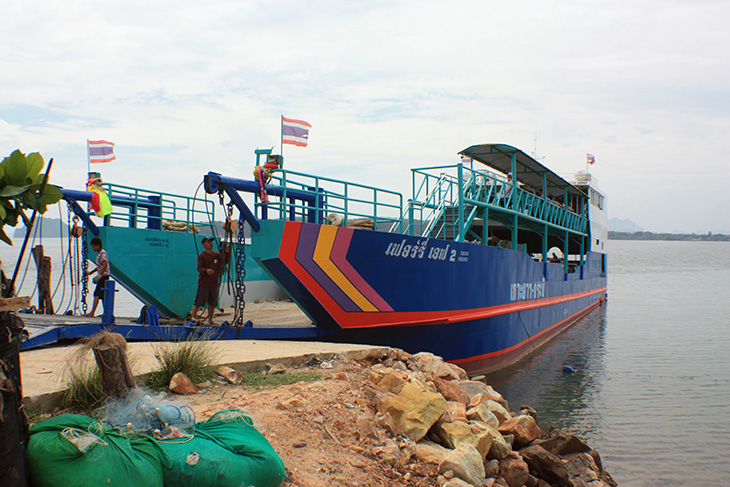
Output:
[365, 350, 616, 487]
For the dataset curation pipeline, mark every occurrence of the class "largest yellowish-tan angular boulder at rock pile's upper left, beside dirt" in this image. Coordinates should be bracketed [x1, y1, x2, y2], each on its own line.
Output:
[384, 381, 446, 441]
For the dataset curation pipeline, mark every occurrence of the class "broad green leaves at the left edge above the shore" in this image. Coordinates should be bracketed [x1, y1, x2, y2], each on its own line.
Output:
[0, 150, 62, 245]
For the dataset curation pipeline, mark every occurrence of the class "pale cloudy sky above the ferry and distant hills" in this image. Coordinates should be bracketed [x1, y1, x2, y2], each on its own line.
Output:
[0, 0, 730, 233]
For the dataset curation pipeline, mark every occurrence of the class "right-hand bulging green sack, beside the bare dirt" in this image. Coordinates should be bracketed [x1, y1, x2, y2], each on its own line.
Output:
[159, 409, 286, 487]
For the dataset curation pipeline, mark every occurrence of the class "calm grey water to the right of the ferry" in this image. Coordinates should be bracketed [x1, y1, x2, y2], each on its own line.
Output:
[488, 241, 730, 487]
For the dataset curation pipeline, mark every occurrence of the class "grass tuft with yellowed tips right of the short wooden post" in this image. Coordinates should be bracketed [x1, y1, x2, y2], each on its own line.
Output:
[146, 339, 220, 390]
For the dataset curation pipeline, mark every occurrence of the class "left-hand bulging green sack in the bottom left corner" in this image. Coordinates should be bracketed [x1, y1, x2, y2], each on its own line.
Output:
[26, 414, 167, 487]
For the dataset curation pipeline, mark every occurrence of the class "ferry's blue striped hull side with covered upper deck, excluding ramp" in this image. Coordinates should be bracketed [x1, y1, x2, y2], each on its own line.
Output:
[205, 144, 607, 374]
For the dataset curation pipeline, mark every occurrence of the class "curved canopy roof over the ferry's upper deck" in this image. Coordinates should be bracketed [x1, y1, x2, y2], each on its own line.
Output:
[459, 144, 587, 198]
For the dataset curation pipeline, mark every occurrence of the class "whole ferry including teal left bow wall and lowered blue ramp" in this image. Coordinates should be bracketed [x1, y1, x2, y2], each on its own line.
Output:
[31, 144, 607, 374]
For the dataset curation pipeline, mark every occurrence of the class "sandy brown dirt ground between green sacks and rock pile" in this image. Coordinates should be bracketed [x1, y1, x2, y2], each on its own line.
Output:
[185, 359, 438, 487]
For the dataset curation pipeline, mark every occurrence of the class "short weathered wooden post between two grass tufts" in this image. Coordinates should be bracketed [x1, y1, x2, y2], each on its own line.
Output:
[88, 332, 137, 397]
